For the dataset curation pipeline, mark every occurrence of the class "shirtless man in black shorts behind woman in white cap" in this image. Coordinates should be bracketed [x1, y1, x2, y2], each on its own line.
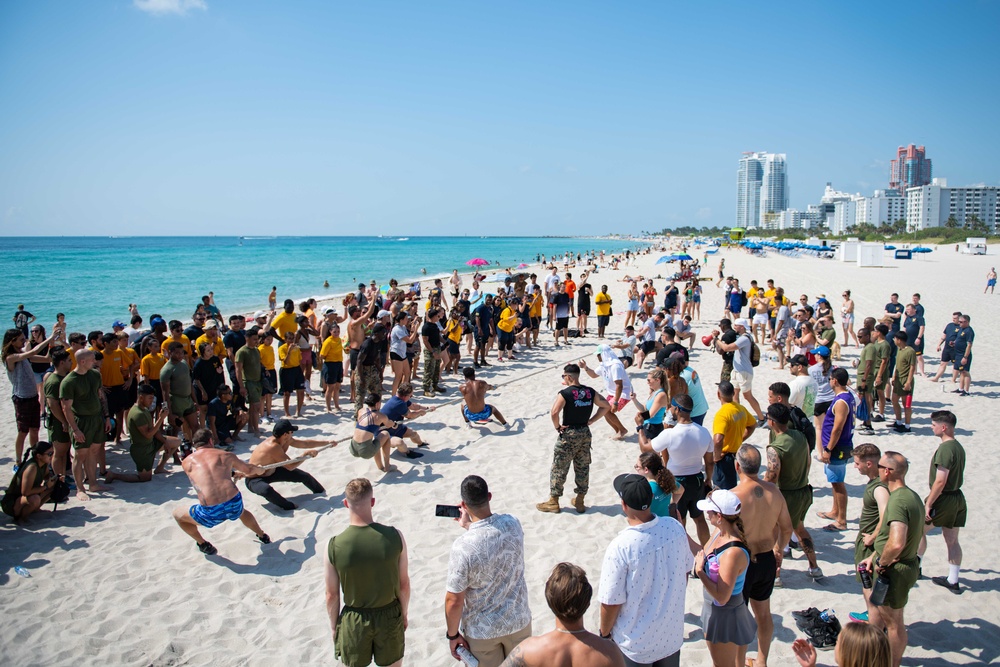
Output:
[733, 443, 792, 667]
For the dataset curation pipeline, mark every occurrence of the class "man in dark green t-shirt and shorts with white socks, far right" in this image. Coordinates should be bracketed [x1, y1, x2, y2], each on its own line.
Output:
[917, 410, 968, 595]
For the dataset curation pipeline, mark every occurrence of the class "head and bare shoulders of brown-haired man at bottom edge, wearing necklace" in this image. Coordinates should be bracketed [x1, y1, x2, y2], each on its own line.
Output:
[500, 563, 625, 667]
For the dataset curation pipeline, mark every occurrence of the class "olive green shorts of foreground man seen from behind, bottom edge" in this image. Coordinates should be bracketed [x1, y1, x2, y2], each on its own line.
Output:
[333, 600, 405, 667]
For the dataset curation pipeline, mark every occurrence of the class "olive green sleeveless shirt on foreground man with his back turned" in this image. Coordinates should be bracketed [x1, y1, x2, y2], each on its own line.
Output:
[327, 523, 403, 609]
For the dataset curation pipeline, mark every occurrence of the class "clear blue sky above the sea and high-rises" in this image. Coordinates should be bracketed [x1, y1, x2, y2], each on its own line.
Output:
[0, 0, 1000, 236]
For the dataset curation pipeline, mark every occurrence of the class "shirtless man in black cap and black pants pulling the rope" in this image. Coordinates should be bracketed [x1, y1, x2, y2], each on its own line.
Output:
[245, 419, 337, 510]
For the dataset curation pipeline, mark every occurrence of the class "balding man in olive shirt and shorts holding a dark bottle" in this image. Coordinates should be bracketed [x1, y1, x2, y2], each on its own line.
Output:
[859, 452, 925, 667]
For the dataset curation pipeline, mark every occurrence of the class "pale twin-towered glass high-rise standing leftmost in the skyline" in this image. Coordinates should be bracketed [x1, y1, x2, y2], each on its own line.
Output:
[736, 152, 788, 228]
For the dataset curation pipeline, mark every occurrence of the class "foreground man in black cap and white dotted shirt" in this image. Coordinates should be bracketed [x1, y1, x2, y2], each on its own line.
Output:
[598, 474, 698, 667]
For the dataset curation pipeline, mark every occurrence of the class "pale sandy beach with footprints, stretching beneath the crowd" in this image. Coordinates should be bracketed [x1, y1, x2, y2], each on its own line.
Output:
[0, 241, 1000, 666]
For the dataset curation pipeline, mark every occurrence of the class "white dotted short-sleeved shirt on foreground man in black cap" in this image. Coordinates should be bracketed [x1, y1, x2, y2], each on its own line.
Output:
[598, 517, 694, 663]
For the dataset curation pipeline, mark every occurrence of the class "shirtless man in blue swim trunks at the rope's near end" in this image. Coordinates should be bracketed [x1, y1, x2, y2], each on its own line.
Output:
[173, 428, 271, 556]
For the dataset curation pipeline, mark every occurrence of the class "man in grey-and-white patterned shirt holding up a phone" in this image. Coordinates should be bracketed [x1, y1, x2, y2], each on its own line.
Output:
[444, 475, 531, 667]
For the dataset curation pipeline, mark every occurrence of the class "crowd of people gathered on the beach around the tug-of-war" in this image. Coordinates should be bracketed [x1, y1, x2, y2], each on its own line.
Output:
[2, 244, 974, 667]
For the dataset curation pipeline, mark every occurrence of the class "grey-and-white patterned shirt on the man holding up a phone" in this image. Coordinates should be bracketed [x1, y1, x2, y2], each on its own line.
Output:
[447, 514, 531, 639]
